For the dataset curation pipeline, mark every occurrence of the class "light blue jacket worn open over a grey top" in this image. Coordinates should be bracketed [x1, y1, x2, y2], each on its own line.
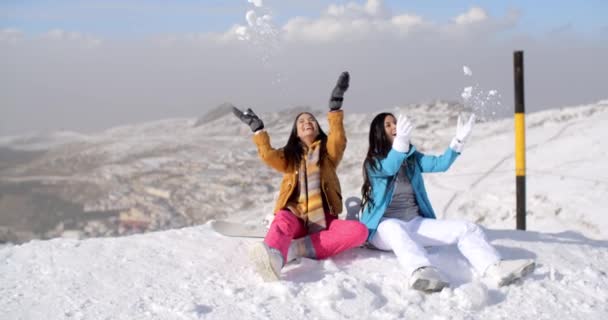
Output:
[360, 145, 460, 240]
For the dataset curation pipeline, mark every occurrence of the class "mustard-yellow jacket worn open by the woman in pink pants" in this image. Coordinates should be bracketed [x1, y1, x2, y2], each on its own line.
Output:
[253, 110, 346, 219]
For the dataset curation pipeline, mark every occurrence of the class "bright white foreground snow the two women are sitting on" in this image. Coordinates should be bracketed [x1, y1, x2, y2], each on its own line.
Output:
[0, 225, 608, 319]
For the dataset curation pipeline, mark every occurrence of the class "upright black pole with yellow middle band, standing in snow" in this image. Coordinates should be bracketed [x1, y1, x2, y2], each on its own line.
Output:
[513, 51, 526, 230]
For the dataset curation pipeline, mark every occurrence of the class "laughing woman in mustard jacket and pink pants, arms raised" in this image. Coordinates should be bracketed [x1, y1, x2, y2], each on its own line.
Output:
[233, 72, 367, 281]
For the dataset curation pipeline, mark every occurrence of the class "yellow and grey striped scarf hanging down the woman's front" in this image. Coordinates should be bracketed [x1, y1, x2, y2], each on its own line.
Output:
[290, 141, 326, 233]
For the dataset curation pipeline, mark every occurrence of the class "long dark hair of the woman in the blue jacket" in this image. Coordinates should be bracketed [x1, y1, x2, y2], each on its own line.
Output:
[361, 112, 395, 208]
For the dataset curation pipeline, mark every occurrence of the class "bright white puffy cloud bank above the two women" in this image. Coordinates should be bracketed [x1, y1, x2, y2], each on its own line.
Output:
[207, 0, 510, 44]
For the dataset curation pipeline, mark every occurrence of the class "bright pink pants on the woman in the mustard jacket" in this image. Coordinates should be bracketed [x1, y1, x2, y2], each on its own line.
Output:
[264, 210, 367, 259]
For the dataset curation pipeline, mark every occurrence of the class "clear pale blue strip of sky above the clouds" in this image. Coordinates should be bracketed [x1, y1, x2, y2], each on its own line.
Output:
[0, 0, 608, 37]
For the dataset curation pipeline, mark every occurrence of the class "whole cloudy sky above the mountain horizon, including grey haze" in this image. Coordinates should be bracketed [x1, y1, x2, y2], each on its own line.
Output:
[0, 0, 608, 135]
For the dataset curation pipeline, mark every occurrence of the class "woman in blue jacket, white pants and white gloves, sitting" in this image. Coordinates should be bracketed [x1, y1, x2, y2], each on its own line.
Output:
[361, 113, 534, 292]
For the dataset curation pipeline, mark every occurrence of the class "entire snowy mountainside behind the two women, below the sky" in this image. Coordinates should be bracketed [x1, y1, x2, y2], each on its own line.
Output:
[0, 101, 608, 242]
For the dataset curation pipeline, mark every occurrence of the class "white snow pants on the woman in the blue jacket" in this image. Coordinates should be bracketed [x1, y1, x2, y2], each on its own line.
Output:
[370, 216, 500, 276]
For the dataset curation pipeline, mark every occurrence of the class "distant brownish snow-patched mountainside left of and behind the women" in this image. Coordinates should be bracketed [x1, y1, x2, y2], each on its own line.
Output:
[0, 102, 462, 242]
